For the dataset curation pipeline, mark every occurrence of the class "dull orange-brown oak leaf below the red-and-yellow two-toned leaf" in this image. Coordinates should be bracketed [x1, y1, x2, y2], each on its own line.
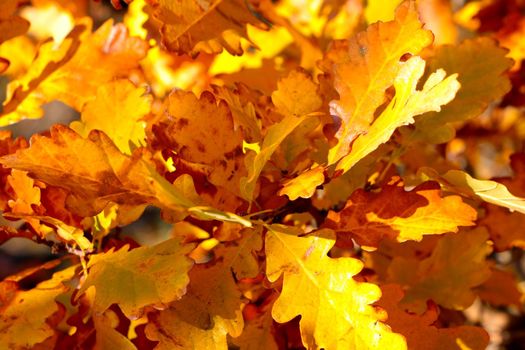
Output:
[388, 228, 492, 313]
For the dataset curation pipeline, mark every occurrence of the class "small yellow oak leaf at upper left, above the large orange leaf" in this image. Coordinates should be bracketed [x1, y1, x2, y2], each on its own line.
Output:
[71, 80, 152, 154]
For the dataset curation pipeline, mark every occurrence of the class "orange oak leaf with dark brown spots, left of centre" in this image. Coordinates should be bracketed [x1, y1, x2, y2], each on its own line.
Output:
[152, 91, 245, 206]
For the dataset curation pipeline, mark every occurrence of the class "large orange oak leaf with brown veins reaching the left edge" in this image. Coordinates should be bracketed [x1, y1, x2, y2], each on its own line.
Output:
[0, 125, 193, 216]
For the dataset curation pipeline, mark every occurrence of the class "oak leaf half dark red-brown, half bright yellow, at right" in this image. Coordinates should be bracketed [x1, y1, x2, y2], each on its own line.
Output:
[325, 181, 477, 248]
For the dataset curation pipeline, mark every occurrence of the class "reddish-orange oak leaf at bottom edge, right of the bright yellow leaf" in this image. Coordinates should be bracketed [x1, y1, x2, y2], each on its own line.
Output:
[377, 284, 489, 350]
